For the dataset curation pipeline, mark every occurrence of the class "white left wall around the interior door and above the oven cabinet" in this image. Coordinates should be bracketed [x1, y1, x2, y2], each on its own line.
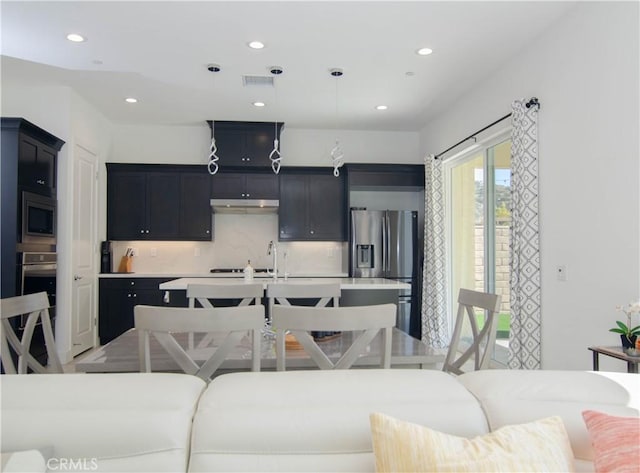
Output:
[1, 83, 111, 362]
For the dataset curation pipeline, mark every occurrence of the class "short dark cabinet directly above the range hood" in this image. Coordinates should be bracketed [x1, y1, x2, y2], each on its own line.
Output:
[211, 171, 279, 200]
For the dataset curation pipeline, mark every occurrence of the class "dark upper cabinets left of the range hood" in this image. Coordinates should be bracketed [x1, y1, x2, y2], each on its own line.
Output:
[107, 164, 212, 240]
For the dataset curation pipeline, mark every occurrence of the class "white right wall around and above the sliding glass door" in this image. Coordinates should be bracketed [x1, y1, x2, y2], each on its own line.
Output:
[420, 2, 640, 371]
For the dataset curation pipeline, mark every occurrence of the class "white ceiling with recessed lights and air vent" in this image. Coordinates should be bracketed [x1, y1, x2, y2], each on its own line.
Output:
[0, 0, 575, 131]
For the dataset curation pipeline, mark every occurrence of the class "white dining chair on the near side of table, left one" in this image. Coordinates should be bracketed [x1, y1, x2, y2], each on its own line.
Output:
[134, 305, 264, 381]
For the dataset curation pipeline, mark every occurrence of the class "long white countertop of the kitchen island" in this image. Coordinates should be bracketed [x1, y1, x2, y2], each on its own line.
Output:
[159, 277, 411, 291]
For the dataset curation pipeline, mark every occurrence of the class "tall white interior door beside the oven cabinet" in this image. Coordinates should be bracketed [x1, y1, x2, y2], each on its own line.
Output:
[71, 145, 98, 356]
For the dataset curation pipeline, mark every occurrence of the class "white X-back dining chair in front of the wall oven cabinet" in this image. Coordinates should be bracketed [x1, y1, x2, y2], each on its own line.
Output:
[0, 292, 63, 374]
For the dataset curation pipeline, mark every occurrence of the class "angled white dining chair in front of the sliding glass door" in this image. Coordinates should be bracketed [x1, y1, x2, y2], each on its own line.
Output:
[442, 289, 500, 374]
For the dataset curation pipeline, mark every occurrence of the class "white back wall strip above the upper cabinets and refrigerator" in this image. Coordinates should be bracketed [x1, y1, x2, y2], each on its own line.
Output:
[108, 122, 422, 166]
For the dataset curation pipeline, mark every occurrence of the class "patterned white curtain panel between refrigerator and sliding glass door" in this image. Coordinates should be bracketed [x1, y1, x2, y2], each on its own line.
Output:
[422, 155, 449, 348]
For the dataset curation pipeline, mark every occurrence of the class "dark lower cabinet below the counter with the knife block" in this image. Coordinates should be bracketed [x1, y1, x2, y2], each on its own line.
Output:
[98, 278, 187, 345]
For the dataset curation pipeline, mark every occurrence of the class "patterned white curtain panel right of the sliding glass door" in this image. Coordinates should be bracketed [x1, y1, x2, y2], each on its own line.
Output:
[509, 100, 541, 369]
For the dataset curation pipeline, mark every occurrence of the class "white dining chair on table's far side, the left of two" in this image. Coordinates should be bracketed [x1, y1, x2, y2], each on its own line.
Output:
[187, 282, 264, 349]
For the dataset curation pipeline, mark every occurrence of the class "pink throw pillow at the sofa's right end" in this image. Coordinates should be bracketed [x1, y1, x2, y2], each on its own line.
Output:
[582, 411, 640, 473]
